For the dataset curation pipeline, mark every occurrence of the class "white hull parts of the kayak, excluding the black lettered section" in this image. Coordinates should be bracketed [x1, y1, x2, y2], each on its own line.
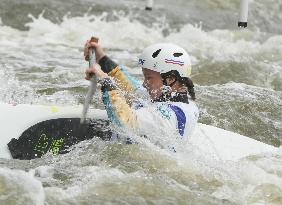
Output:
[0, 103, 278, 161]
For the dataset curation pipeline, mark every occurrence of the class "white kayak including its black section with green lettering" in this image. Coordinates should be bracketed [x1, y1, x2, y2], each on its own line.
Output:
[0, 103, 278, 161]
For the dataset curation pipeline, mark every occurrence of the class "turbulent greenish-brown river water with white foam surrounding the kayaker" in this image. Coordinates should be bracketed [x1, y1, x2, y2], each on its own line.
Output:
[0, 0, 282, 205]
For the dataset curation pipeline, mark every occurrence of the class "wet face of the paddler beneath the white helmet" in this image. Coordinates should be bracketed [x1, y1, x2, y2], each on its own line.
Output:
[142, 68, 163, 100]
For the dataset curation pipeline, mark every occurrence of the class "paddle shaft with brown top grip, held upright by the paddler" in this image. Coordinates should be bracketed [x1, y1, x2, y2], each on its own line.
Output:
[80, 37, 99, 123]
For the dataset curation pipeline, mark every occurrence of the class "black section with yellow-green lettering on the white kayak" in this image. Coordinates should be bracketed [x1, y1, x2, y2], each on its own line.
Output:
[8, 118, 112, 160]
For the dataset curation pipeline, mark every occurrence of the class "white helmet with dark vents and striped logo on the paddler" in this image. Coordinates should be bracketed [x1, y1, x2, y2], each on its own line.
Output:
[138, 43, 192, 77]
